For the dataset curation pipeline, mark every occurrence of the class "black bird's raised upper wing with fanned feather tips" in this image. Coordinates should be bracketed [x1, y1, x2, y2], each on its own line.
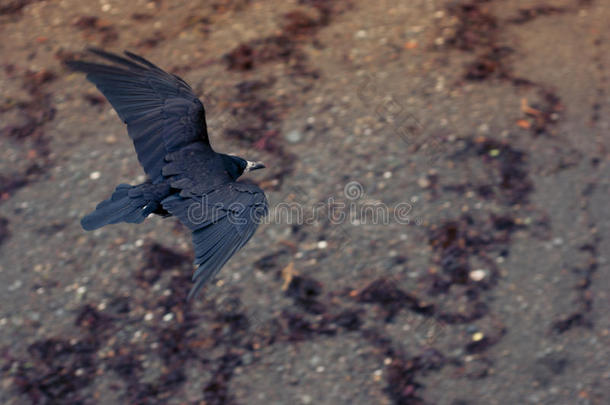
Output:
[66, 49, 210, 179]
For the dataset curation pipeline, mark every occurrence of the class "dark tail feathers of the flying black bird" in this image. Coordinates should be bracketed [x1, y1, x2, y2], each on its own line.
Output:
[81, 184, 159, 231]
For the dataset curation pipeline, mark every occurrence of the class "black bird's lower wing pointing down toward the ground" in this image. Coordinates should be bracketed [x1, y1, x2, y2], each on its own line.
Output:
[162, 182, 268, 299]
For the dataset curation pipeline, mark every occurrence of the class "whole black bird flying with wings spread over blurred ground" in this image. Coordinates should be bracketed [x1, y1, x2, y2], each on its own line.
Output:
[66, 49, 268, 298]
